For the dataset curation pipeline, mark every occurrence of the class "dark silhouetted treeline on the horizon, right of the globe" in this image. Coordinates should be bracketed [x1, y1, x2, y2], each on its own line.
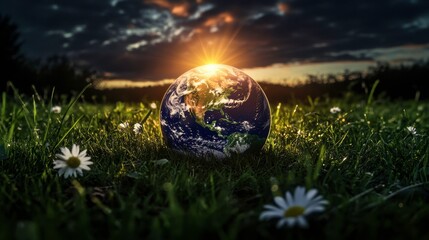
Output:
[288, 60, 429, 101]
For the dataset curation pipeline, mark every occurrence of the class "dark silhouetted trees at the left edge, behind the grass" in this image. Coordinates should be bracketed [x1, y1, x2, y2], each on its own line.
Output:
[0, 16, 97, 95]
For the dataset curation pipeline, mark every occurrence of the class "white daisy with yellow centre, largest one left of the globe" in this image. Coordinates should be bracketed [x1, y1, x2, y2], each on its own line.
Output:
[54, 144, 92, 178]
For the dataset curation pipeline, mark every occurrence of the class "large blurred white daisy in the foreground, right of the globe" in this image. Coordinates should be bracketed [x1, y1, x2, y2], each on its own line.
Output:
[259, 187, 328, 228]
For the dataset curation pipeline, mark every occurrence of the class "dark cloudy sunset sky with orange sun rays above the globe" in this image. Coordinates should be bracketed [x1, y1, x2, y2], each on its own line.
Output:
[0, 0, 429, 86]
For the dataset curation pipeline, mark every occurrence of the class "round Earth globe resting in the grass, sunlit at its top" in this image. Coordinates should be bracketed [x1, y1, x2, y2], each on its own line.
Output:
[160, 64, 271, 158]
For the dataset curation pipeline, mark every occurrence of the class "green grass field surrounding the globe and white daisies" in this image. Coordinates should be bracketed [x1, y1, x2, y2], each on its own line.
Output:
[0, 90, 429, 239]
